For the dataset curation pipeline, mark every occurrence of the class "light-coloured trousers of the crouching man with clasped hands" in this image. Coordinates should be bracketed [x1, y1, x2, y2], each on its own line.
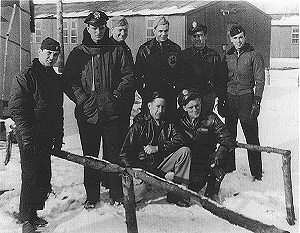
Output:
[157, 147, 191, 184]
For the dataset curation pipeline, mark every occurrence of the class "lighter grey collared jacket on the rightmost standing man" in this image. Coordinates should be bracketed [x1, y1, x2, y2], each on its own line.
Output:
[224, 43, 265, 97]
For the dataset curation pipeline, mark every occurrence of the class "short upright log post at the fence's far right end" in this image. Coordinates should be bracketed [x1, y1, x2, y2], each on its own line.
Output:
[282, 151, 296, 225]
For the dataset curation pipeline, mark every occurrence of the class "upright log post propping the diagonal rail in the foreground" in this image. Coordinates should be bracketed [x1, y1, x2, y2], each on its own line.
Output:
[122, 171, 138, 233]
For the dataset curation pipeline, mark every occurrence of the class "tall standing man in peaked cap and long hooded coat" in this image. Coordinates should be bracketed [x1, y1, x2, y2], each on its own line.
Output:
[64, 11, 134, 208]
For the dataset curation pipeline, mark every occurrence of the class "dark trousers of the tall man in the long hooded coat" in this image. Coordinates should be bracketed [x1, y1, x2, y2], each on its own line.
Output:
[77, 120, 123, 203]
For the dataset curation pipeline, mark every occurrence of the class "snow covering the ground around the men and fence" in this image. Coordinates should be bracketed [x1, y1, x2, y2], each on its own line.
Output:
[0, 59, 299, 233]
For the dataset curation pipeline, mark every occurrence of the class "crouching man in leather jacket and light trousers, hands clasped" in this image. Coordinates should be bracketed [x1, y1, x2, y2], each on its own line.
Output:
[120, 91, 191, 207]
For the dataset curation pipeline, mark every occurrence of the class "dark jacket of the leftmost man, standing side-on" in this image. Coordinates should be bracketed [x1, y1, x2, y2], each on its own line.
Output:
[9, 58, 63, 148]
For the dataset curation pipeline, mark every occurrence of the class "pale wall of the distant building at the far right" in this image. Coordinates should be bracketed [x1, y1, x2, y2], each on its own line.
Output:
[271, 26, 299, 58]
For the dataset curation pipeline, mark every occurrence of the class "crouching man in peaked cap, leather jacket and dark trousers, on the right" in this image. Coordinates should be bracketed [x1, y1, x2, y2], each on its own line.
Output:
[178, 88, 235, 202]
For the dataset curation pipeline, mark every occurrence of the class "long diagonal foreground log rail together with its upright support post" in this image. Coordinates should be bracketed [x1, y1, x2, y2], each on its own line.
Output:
[54, 151, 288, 233]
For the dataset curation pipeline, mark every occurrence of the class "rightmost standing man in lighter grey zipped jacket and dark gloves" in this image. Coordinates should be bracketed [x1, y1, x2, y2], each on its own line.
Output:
[218, 26, 265, 180]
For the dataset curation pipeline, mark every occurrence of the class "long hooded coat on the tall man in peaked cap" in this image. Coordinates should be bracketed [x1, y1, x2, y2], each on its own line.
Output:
[64, 29, 134, 124]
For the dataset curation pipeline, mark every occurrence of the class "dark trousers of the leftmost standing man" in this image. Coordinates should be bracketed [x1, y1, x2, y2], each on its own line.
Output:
[16, 132, 52, 221]
